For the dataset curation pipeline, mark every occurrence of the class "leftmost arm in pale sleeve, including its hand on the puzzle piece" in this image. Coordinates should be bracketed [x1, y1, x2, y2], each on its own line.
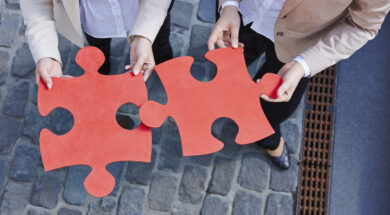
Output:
[20, 0, 62, 89]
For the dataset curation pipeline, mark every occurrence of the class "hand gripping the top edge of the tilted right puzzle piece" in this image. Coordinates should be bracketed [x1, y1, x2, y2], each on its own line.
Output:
[207, 6, 244, 50]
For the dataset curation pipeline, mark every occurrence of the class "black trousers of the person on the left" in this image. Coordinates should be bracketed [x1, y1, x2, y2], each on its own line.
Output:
[84, 1, 174, 75]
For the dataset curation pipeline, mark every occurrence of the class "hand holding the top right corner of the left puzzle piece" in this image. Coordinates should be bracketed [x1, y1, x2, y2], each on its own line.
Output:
[125, 36, 156, 81]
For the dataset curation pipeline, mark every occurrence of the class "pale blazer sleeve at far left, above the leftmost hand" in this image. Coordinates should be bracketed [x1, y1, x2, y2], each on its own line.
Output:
[20, 0, 61, 63]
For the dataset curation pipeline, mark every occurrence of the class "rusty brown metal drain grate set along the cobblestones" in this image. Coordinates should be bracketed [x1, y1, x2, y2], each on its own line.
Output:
[297, 66, 336, 215]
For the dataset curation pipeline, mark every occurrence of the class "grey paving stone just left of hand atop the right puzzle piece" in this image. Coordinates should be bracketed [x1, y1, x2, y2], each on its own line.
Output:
[188, 25, 211, 62]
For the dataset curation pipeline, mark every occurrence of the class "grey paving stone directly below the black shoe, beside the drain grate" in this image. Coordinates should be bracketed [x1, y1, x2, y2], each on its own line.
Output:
[269, 157, 299, 193]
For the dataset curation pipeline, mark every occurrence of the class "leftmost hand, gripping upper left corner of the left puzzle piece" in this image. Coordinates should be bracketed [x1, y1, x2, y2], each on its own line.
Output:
[35, 57, 63, 89]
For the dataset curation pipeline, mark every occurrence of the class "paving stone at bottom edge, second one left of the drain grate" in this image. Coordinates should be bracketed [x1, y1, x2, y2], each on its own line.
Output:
[233, 191, 263, 215]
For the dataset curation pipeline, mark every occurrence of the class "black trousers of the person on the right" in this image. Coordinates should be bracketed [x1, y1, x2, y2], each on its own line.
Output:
[239, 22, 309, 150]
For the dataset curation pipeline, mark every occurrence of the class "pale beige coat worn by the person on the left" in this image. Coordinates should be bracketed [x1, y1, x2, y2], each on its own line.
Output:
[20, 0, 171, 62]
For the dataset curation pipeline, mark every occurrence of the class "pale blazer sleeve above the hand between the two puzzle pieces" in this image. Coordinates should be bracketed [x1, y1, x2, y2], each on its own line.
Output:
[128, 0, 172, 43]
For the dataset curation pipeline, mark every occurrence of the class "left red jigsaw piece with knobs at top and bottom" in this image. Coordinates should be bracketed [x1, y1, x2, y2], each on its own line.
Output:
[38, 47, 152, 197]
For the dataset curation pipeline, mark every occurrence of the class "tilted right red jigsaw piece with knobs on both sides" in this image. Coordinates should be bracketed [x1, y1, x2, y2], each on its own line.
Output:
[139, 48, 282, 156]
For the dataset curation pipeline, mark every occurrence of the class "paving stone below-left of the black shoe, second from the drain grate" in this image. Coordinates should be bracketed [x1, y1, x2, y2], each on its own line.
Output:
[238, 153, 270, 192]
